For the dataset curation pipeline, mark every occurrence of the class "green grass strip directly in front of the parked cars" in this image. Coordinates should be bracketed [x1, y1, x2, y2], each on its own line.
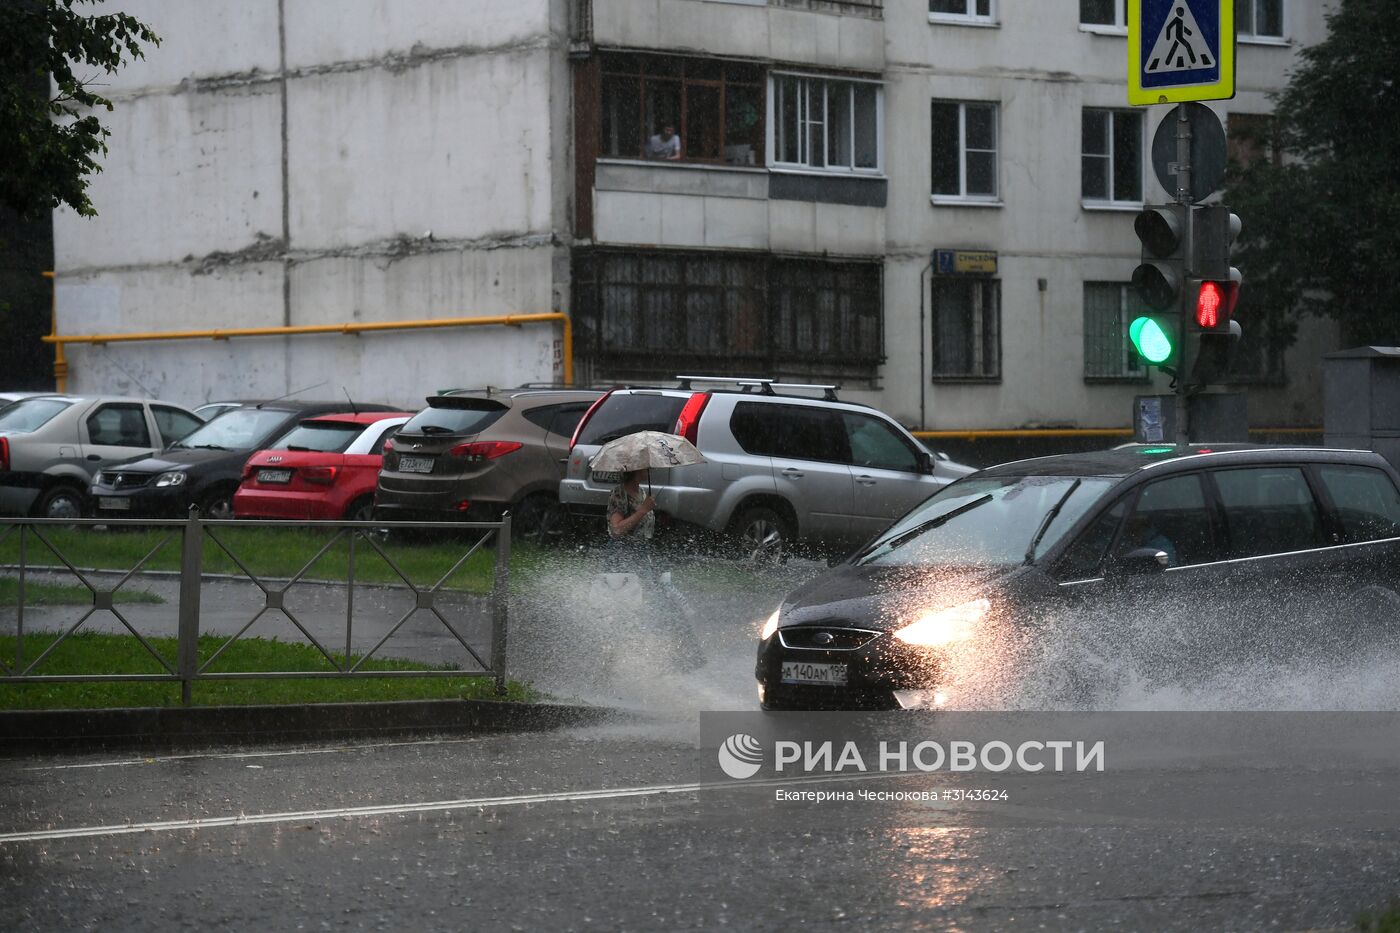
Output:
[0, 527, 509, 593]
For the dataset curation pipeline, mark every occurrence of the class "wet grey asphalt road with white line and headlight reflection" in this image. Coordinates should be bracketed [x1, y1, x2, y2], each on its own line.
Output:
[0, 721, 1400, 930]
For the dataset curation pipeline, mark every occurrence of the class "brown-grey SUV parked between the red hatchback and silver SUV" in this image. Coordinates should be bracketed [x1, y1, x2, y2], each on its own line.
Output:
[374, 388, 602, 535]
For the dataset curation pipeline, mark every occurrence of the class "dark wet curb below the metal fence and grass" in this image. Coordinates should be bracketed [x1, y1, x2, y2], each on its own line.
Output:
[0, 699, 615, 754]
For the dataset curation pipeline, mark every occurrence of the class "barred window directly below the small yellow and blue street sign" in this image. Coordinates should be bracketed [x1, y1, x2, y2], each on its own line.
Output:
[932, 277, 1001, 380]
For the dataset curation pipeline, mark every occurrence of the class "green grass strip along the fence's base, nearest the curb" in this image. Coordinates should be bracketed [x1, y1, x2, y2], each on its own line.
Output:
[0, 632, 538, 709]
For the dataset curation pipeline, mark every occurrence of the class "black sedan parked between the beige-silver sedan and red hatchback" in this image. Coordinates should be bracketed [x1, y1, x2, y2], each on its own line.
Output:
[91, 401, 393, 518]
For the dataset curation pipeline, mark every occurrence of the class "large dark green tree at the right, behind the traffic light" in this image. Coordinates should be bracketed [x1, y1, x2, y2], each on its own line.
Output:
[1226, 0, 1400, 345]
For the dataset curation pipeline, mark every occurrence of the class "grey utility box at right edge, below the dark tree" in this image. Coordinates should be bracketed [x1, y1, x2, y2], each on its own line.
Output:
[1322, 346, 1400, 469]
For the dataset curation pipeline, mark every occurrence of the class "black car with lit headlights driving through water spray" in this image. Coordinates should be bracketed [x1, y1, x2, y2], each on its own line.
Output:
[756, 445, 1400, 709]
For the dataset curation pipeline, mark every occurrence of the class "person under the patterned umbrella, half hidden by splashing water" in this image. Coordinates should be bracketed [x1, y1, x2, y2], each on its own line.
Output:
[608, 469, 706, 671]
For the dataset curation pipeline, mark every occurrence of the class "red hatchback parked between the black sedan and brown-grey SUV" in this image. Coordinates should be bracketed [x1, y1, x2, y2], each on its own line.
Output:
[234, 412, 412, 521]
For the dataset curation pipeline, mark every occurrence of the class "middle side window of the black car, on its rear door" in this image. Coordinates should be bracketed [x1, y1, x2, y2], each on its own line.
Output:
[1215, 467, 1322, 558]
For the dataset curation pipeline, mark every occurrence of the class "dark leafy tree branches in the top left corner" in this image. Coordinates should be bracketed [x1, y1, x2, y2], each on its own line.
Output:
[0, 0, 160, 217]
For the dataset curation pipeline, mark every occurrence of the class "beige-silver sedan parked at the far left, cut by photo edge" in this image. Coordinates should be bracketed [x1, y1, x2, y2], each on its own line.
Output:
[0, 395, 203, 518]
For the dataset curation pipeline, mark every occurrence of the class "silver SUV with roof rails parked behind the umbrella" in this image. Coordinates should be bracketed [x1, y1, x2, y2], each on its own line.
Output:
[559, 377, 973, 558]
